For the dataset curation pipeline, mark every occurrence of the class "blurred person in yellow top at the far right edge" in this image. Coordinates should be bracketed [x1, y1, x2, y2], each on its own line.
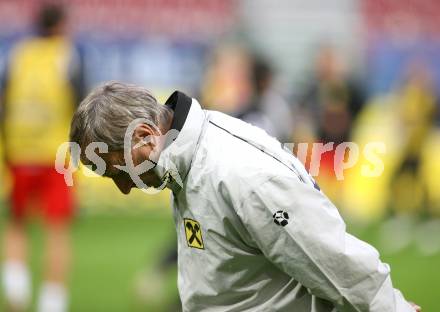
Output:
[390, 61, 438, 214]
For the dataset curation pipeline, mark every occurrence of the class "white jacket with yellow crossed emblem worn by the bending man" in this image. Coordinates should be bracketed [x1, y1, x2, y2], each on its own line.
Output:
[155, 92, 414, 312]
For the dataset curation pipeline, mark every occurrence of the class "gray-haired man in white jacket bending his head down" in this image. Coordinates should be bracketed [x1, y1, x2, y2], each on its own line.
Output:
[71, 82, 419, 312]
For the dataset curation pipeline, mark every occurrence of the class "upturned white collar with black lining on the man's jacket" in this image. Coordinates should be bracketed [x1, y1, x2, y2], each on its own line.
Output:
[154, 91, 205, 192]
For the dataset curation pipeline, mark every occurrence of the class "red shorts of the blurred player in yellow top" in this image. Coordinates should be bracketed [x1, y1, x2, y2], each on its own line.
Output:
[10, 166, 74, 222]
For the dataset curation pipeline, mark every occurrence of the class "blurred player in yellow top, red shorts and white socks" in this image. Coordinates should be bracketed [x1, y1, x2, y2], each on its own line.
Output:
[1, 3, 83, 312]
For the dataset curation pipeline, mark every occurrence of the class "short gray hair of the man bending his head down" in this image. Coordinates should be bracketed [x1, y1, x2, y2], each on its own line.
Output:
[70, 81, 172, 151]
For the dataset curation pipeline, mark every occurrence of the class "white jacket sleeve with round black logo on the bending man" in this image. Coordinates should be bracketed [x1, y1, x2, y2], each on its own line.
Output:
[237, 176, 415, 312]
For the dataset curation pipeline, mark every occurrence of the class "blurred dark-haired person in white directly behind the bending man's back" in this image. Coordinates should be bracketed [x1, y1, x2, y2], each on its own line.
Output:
[236, 56, 293, 143]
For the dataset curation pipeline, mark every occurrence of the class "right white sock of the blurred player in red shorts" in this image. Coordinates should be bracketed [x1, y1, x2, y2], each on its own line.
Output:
[38, 282, 68, 312]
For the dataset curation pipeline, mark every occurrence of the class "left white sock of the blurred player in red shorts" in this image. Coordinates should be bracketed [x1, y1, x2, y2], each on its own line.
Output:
[2, 261, 31, 309]
